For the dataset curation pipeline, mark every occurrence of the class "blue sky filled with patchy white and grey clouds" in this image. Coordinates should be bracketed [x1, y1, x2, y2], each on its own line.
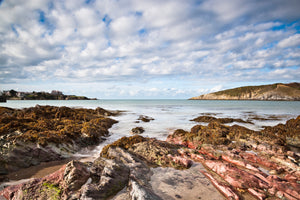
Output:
[0, 0, 300, 99]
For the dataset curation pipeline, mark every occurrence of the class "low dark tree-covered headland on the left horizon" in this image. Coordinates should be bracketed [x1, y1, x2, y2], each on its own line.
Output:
[0, 90, 96, 102]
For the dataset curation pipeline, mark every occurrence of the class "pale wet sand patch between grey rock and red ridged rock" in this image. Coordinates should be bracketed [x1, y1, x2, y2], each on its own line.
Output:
[151, 163, 225, 200]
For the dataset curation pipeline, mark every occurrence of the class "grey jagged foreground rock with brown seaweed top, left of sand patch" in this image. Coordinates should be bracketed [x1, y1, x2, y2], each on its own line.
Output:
[0, 136, 191, 200]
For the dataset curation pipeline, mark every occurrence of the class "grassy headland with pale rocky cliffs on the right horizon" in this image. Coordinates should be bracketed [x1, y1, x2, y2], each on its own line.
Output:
[190, 83, 300, 101]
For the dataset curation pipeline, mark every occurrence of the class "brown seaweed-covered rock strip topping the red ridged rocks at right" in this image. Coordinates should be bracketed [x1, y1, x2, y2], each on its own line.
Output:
[167, 117, 300, 152]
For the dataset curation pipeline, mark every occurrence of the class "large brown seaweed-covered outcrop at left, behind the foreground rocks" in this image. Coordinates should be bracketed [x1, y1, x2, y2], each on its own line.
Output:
[0, 105, 116, 175]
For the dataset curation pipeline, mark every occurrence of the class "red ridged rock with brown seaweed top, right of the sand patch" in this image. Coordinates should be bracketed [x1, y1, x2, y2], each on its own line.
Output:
[167, 116, 300, 199]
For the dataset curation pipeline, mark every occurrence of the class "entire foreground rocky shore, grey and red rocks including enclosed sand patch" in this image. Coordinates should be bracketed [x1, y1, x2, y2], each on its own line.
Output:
[0, 116, 300, 200]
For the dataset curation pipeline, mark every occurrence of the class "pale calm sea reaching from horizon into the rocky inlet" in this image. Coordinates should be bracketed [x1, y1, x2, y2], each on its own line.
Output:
[0, 99, 300, 158]
